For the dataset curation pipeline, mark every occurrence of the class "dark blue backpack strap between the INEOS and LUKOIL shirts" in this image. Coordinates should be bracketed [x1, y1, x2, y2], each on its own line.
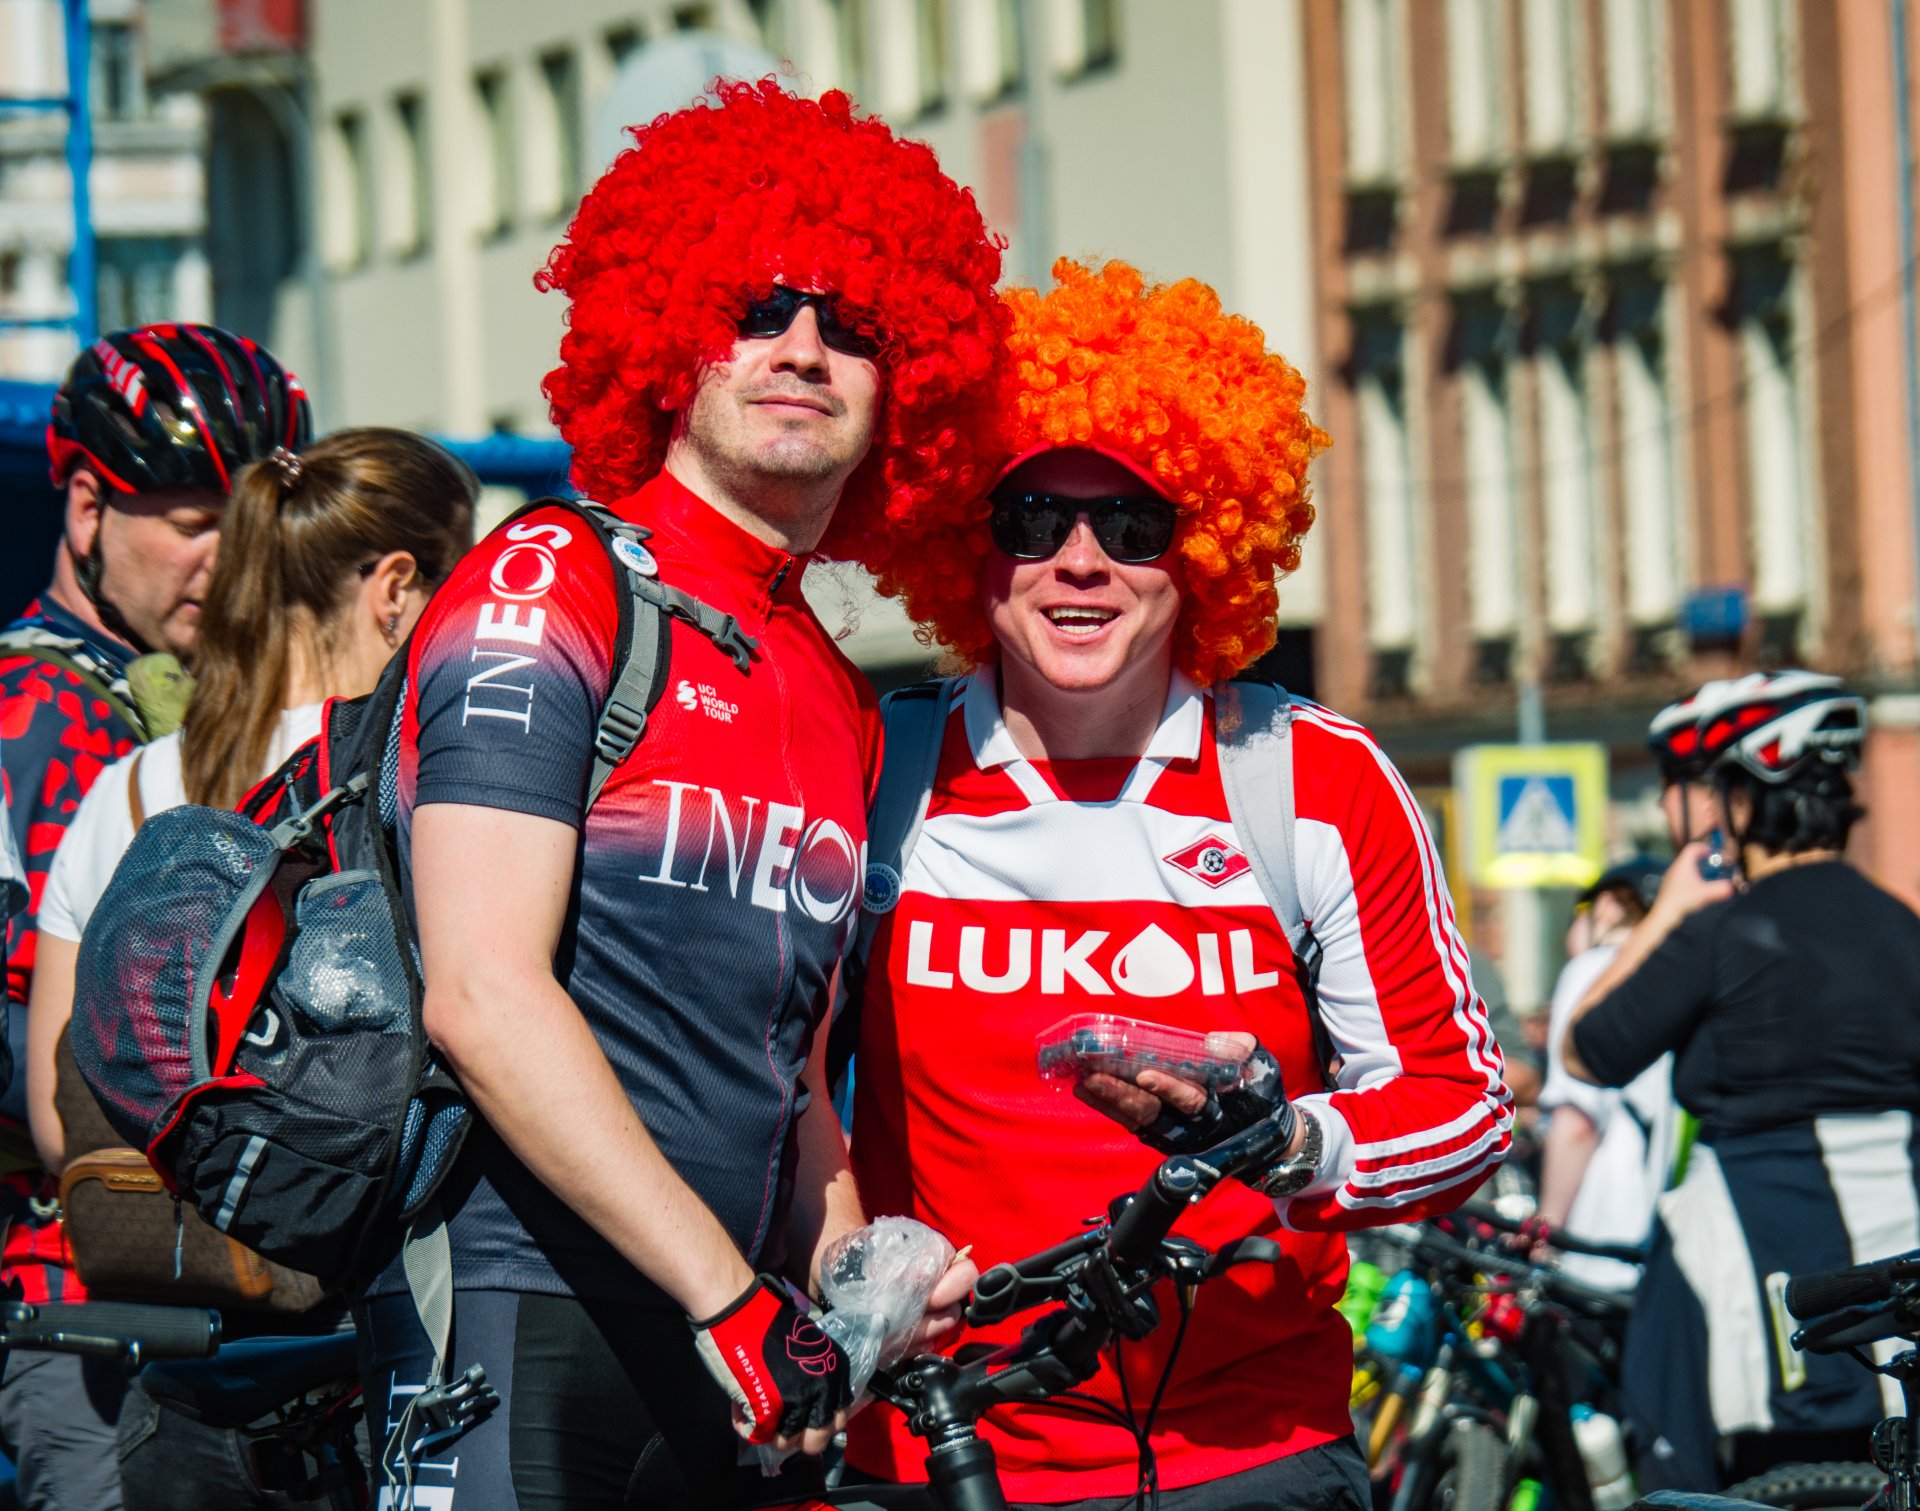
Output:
[828, 678, 956, 1087]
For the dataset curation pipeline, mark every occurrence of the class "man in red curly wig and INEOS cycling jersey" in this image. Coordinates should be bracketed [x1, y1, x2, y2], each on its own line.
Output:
[359, 83, 1004, 1511]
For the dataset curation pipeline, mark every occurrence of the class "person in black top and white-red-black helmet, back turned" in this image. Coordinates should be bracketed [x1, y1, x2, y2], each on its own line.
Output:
[1565, 672, 1920, 1490]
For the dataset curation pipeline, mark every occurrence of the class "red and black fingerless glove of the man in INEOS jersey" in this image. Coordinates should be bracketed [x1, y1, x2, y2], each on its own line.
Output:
[693, 1275, 852, 1442]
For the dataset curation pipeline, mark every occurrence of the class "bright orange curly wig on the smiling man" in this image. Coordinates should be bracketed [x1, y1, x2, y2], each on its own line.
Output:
[868, 257, 1327, 685]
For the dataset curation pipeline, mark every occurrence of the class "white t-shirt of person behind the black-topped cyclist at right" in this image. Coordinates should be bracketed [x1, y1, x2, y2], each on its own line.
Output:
[1540, 945, 1678, 1290]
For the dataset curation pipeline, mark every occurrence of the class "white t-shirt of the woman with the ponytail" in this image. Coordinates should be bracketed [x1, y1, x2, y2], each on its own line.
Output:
[38, 703, 323, 945]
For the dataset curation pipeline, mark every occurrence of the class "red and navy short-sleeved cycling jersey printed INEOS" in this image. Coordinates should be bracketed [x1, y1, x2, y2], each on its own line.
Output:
[376, 474, 879, 1304]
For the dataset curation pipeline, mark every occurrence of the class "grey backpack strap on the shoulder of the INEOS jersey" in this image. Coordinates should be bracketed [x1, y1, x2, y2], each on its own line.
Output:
[503, 497, 758, 808]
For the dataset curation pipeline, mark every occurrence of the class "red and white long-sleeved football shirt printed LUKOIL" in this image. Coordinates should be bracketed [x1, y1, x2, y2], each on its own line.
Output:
[849, 672, 1511, 1501]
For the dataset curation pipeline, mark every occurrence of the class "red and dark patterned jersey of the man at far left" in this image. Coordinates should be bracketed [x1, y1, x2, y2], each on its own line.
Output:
[0, 601, 136, 1302]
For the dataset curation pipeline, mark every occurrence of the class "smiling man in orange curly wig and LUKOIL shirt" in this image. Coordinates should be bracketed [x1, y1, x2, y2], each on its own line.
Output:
[847, 261, 1511, 1511]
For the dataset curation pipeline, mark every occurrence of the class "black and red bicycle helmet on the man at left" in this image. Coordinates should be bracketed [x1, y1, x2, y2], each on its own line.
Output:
[46, 324, 313, 495]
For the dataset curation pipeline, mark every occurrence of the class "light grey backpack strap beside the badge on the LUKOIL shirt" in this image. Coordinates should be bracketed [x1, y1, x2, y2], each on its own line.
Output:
[1213, 678, 1334, 1089]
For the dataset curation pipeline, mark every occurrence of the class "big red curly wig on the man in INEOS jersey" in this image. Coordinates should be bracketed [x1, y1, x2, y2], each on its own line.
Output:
[534, 79, 1006, 559]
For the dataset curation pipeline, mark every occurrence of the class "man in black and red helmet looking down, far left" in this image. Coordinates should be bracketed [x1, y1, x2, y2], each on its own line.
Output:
[0, 324, 311, 1507]
